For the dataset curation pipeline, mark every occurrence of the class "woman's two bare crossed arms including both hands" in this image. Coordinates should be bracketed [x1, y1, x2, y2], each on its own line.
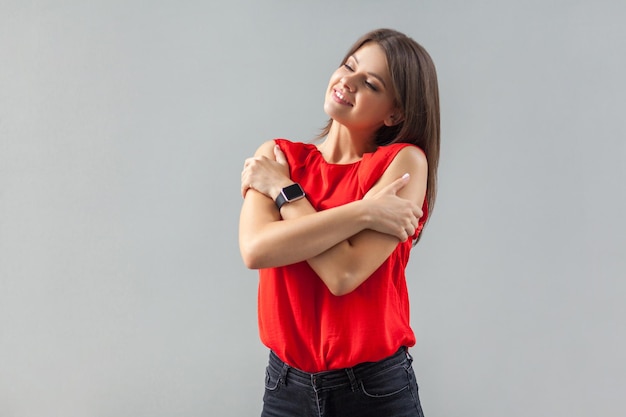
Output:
[239, 142, 426, 295]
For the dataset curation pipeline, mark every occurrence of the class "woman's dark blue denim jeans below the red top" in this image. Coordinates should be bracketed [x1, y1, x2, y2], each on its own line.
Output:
[261, 348, 424, 417]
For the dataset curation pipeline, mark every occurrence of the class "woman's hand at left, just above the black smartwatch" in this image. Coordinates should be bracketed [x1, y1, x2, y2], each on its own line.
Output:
[241, 145, 293, 199]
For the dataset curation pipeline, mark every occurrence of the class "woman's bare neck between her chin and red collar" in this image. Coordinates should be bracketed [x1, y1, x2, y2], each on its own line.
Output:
[318, 121, 377, 164]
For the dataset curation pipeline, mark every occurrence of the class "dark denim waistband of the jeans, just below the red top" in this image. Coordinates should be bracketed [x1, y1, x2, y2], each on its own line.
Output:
[269, 346, 413, 389]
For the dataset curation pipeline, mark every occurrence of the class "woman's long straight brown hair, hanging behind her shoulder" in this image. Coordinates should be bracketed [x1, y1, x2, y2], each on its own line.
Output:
[319, 29, 440, 229]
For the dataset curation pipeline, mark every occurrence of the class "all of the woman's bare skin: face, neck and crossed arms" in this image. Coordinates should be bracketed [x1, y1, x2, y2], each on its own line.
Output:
[239, 43, 427, 296]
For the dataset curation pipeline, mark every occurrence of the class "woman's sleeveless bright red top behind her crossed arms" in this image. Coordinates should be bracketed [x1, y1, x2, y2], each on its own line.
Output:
[258, 139, 428, 373]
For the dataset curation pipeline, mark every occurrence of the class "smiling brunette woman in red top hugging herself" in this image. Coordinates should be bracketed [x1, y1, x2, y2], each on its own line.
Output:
[239, 29, 440, 417]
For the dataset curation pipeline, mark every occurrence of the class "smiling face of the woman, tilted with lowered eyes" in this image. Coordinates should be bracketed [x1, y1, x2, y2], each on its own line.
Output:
[324, 42, 400, 135]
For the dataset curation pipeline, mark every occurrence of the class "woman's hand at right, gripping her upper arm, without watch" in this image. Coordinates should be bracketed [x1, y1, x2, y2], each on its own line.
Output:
[363, 174, 424, 242]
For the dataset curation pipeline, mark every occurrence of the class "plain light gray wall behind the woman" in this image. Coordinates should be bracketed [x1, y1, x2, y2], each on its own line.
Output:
[0, 0, 626, 417]
